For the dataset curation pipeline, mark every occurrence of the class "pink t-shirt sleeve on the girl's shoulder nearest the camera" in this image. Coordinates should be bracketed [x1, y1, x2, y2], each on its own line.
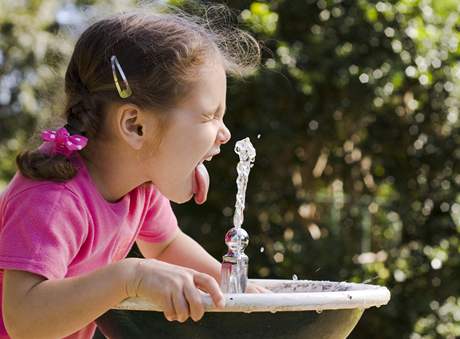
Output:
[0, 183, 88, 279]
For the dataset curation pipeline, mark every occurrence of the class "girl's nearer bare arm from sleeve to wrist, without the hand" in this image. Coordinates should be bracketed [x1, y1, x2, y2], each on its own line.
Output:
[3, 261, 133, 338]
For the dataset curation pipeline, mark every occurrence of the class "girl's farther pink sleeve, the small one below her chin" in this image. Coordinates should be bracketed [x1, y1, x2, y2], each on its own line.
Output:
[137, 185, 179, 243]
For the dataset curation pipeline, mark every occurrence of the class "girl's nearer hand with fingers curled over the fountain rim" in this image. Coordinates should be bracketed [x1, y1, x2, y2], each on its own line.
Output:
[126, 259, 225, 322]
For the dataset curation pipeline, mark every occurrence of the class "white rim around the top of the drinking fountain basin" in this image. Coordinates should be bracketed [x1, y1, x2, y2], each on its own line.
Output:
[115, 279, 391, 313]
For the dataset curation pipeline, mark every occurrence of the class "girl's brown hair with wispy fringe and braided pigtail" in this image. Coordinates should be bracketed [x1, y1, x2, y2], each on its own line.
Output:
[16, 5, 260, 181]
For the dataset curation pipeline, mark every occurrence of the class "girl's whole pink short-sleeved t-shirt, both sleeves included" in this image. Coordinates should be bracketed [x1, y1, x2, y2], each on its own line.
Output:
[0, 156, 178, 339]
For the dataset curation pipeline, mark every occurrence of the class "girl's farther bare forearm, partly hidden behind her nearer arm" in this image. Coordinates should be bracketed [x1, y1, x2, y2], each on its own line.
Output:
[136, 230, 221, 282]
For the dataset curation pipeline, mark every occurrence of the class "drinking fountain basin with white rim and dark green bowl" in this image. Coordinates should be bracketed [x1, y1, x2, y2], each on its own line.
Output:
[98, 279, 390, 339]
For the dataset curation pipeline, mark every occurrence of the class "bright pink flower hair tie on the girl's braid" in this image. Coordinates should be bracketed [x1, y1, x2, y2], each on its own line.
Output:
[41, 127, 88, 158]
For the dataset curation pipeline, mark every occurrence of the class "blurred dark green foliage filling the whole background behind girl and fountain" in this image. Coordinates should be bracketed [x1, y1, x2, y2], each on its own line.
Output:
[0, 0, 460, 339]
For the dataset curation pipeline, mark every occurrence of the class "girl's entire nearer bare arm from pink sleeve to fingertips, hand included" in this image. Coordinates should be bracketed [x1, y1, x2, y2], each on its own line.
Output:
[3, 258, 224, 339]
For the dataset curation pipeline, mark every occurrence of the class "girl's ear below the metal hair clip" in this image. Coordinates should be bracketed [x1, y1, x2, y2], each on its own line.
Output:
[117, 105, 146, 150]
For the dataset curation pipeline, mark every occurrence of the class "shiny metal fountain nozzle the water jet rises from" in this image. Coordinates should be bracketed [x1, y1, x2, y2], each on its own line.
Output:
[221, 227, 249, 293]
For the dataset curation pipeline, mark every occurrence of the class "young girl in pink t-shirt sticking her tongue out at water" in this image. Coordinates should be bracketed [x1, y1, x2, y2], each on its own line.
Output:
[0, 5, 259, 338]
